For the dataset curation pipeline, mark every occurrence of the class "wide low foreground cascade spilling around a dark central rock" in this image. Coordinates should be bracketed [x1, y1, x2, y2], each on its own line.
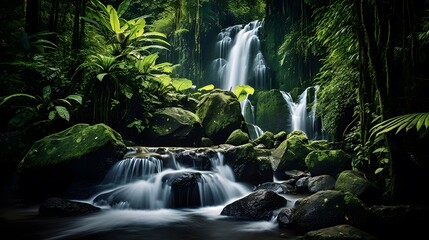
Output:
[92, 148, 249, 209]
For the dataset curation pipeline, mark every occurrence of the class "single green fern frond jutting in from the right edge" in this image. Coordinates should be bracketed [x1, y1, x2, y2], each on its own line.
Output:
[371, 113, 429, 136]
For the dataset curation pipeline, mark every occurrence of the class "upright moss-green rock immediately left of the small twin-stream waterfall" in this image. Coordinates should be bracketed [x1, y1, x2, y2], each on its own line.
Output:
[255, 89, 291, 133]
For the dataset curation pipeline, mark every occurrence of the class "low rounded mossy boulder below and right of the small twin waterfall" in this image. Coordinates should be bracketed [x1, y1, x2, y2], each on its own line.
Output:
[305, 149, 352, 177]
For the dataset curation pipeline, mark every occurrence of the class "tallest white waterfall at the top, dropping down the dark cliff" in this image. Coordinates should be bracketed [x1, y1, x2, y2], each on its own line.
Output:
[212, 20, 271, 91]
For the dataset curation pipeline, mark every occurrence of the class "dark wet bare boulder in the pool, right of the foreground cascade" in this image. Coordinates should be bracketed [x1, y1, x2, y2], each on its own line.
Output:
[220, 189, 287, 221]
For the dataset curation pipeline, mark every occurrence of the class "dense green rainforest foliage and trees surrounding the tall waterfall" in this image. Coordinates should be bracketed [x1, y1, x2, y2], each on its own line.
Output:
[0, 0, 429, 208]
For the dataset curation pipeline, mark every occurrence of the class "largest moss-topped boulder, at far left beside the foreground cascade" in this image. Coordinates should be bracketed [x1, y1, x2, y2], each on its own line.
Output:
[18, 124, 126, 200]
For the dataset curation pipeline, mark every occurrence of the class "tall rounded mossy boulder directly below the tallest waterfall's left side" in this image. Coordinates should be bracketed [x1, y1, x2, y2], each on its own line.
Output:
[196, 90, 248, 144]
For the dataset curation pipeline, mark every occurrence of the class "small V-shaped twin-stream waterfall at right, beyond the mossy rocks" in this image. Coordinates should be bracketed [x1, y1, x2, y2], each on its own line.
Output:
[280, 86, 321, 139]
